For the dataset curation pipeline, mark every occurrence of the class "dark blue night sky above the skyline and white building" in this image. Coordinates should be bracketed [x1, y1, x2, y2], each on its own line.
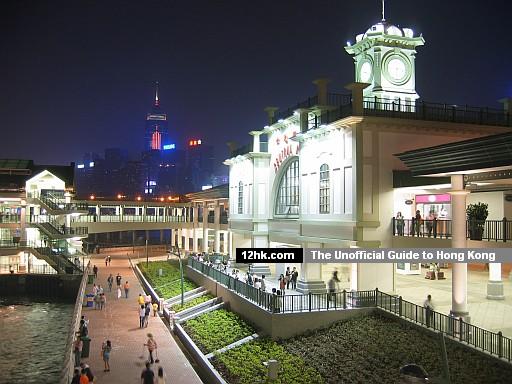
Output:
[0, 0, 512, 171]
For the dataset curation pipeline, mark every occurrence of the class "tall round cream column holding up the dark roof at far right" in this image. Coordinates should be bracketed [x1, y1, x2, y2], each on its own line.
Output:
[449, 175, 469, 322]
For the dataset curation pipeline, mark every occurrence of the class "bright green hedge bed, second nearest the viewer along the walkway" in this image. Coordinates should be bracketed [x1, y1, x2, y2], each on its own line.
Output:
[183, 309, 254, 354]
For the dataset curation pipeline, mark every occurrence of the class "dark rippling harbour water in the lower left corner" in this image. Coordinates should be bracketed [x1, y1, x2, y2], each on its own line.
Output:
[0, 296, 74, 384]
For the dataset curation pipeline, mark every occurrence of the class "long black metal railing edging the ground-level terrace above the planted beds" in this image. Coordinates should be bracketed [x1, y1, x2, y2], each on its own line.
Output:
[188, 257, 512, 362]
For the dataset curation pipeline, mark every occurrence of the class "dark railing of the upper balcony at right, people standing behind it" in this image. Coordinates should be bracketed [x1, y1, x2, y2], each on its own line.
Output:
[391, 217, 512, 242]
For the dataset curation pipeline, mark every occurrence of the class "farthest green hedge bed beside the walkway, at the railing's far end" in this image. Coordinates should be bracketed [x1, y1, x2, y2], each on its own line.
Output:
[138, 261, 197, 299]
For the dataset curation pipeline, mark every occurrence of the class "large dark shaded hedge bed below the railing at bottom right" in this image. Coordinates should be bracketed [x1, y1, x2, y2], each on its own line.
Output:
[283, 316, 512, 384]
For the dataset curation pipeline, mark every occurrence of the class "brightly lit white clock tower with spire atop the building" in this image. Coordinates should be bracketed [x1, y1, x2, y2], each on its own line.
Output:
[345, 6, 425, 110]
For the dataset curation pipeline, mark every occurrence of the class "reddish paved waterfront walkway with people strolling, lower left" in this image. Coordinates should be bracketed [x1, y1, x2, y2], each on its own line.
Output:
[82, 255, 202, 384]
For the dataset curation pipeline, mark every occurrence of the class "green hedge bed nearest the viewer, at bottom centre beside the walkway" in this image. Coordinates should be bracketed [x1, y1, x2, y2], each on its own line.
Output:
[212, 339, 322, 384]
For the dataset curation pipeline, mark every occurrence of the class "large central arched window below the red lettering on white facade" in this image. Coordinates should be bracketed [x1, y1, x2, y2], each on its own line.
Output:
[275, 159, 299, 217]
